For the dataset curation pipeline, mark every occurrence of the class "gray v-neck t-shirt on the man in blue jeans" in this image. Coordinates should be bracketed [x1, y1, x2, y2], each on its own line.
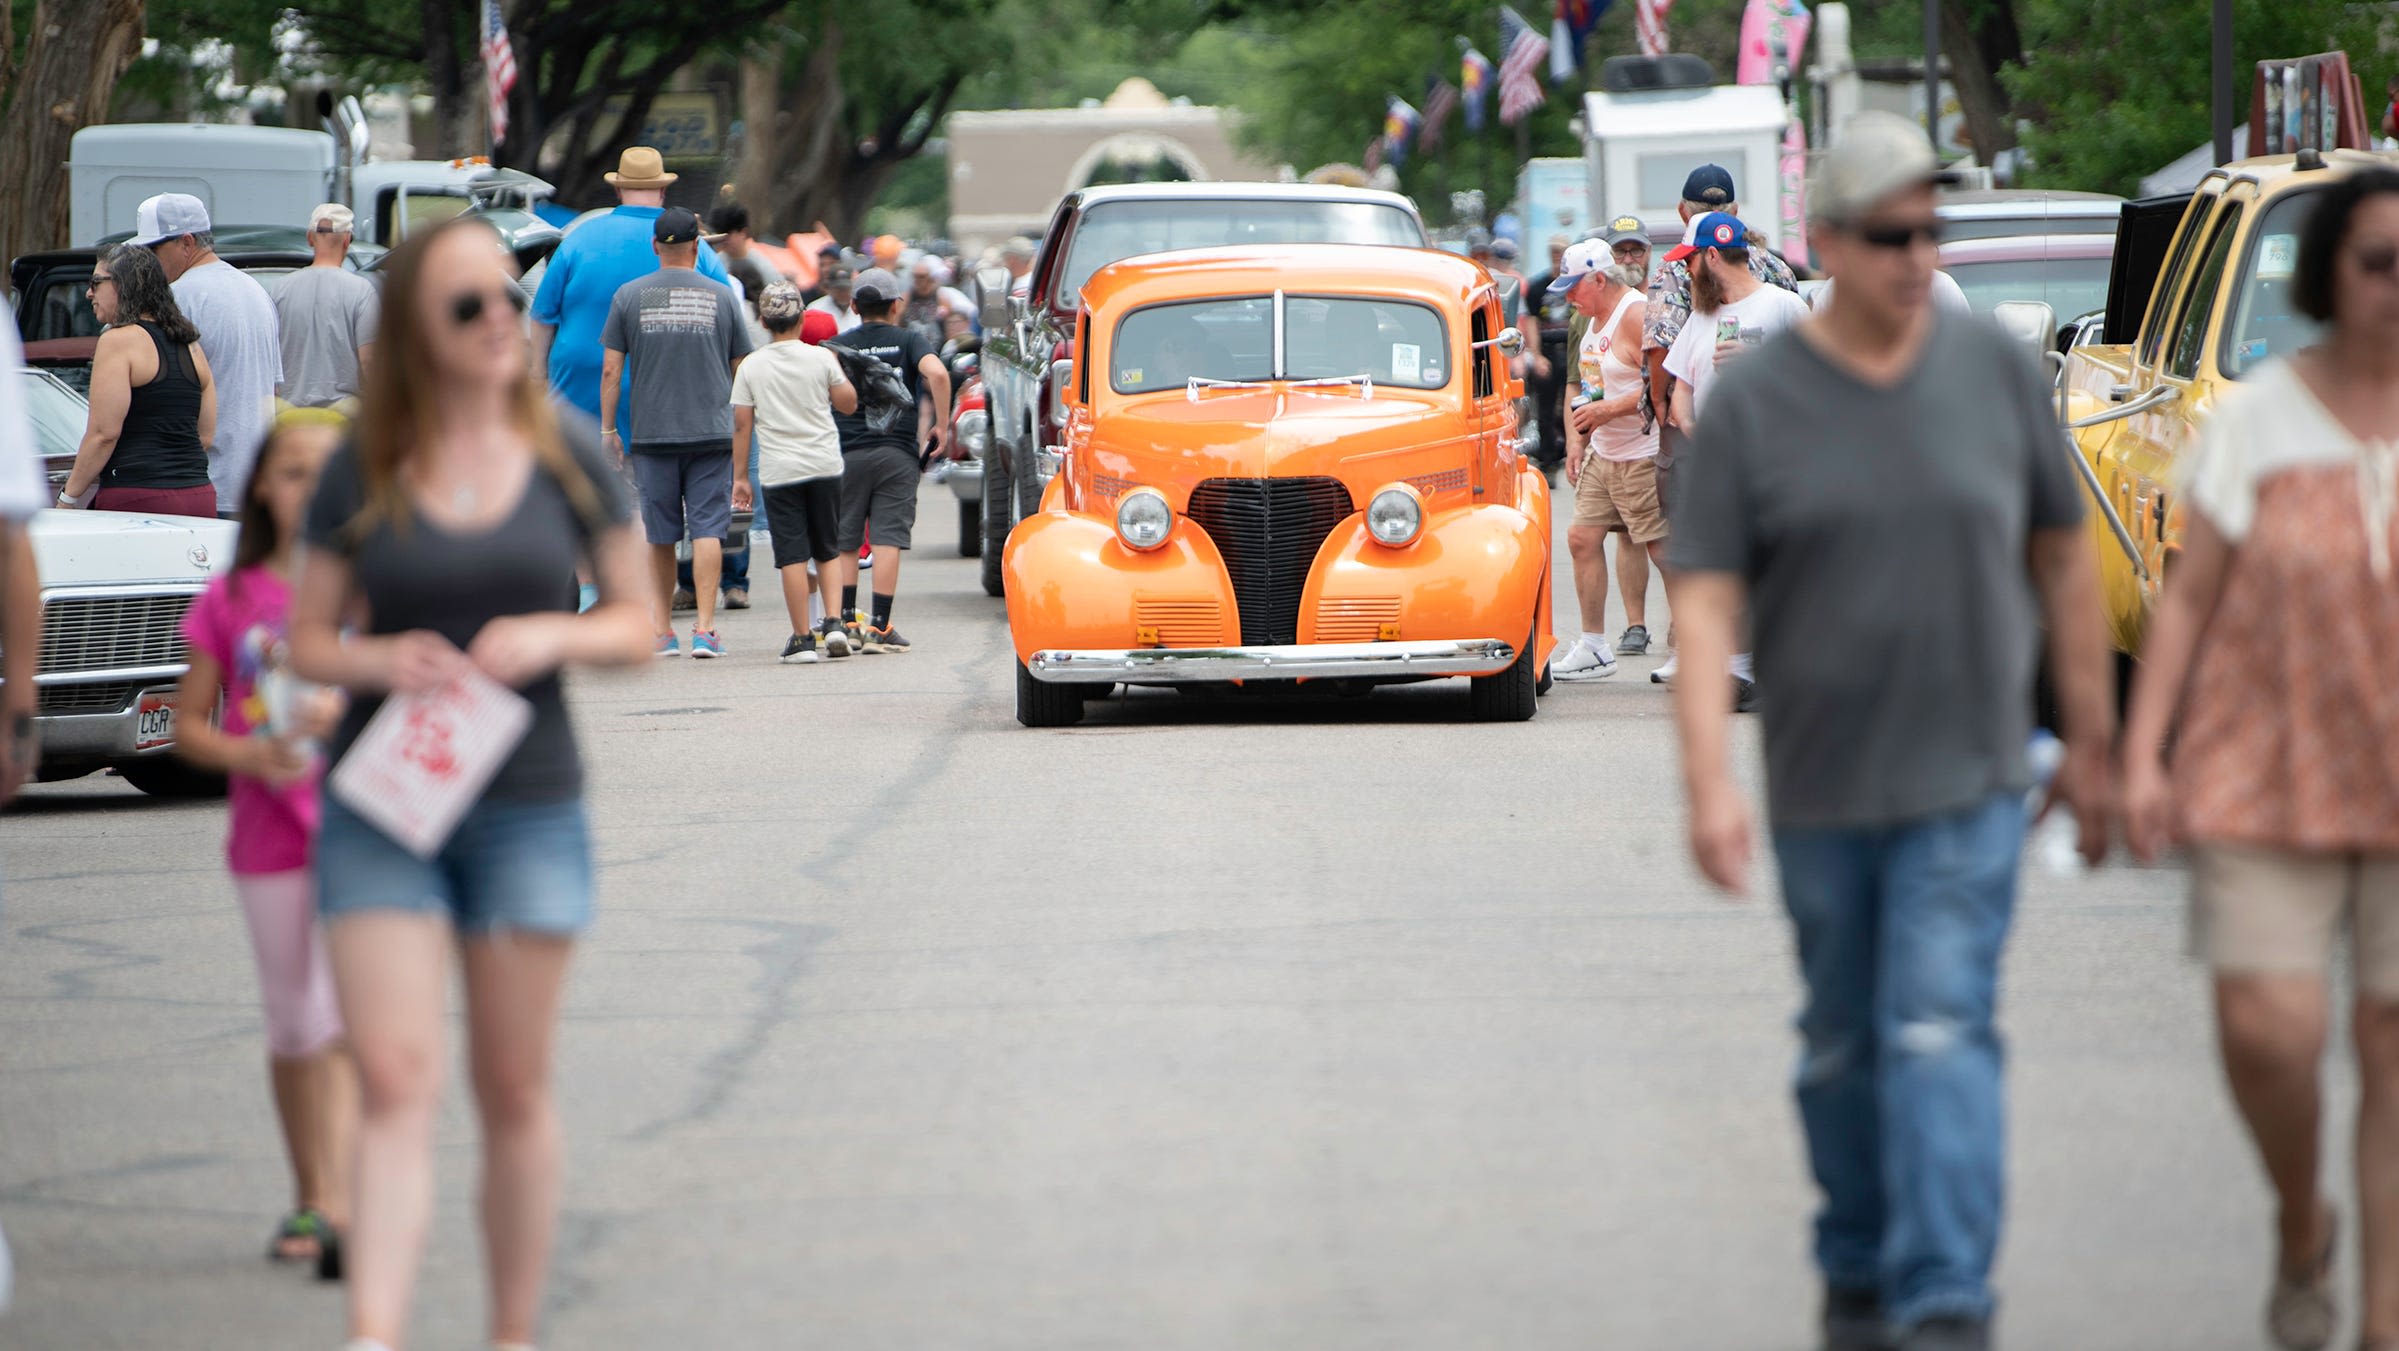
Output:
[1667, 314, 2082, 828]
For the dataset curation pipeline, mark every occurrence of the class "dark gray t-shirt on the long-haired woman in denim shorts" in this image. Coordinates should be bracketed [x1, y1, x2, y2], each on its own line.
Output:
[302, 410, 633, 801]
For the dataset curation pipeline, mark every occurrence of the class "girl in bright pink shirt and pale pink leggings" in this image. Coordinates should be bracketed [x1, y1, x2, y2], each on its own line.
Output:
[175, 408, 357, 1279]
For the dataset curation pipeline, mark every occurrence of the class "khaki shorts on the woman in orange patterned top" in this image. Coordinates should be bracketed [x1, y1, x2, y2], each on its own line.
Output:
[2190, 845, 2399, 998]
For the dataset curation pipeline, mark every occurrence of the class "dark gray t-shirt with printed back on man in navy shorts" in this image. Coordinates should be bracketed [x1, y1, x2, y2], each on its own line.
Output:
[600, 266, 748, 454]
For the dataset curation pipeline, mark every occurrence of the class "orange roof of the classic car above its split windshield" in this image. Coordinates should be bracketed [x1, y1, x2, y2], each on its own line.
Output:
[1082, 245, 1492, 310]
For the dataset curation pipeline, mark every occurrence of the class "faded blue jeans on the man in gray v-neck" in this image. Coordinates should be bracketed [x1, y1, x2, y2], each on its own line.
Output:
[1775, 792, 2025, 1329]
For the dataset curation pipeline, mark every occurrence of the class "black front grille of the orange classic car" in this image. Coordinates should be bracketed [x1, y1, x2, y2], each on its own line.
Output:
[1188, 478, 1358, 646]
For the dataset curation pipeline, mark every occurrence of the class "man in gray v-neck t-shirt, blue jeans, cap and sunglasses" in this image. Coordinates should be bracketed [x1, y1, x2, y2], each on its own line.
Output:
[1667, 113, 2114, 1351]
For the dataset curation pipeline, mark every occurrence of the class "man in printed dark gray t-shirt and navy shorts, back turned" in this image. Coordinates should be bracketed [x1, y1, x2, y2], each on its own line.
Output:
[600, 206, 751, 658]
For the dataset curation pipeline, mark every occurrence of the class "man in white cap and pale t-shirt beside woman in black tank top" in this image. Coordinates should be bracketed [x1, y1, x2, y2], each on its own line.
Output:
[130, 192, 283, 516]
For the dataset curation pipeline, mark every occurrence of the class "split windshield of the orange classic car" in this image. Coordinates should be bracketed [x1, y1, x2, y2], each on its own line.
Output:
[1108, 295, 1449, 394]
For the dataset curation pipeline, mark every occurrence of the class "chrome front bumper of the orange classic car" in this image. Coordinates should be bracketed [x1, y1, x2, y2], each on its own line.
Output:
[1027, 638, 1516, 684]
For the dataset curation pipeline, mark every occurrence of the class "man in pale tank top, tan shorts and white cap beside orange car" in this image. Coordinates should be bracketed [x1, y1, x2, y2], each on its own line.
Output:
[1550, 240, 1665, 681]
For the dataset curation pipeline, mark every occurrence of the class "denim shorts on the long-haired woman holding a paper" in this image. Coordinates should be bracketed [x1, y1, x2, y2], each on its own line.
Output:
[317, 792, 593, 936]
